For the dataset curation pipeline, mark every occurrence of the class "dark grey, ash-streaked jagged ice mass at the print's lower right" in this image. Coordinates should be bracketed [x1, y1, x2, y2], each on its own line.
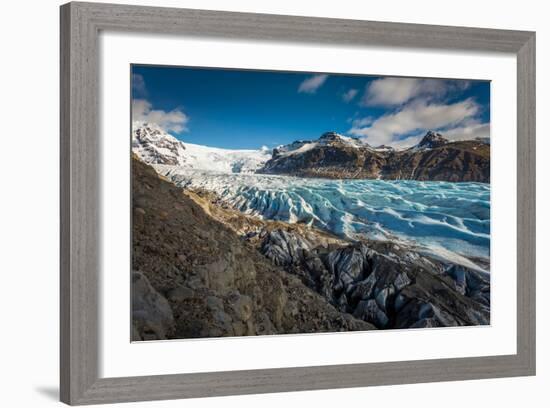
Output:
[260, 230, 490, 329]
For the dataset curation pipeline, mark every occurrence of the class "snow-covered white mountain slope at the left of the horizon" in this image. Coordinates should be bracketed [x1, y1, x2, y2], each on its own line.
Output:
[132, 122, 271, 173]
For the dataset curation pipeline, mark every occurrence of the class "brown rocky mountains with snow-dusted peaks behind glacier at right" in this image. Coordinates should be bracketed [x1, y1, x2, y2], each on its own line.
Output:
[258, 131, 490, 183]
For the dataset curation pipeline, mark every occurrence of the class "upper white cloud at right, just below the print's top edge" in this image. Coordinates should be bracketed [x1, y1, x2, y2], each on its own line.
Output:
[361, 78, 470, 107]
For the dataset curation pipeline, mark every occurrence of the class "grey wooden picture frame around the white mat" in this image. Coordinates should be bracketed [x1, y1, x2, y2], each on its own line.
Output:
[60, 3, 535, 405]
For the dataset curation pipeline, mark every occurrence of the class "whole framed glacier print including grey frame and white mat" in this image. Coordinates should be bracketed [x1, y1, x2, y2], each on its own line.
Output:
[61, 3, 535, 404]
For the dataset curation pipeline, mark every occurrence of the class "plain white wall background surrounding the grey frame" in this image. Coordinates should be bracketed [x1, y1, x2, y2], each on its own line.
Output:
[0, 0, 550, 408]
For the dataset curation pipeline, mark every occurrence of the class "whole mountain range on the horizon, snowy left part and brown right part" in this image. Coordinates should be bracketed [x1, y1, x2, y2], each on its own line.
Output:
[132, 122, 490, 183]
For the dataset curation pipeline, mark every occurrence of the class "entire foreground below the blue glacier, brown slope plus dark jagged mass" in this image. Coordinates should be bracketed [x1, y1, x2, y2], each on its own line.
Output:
[132, 158, 490, 340]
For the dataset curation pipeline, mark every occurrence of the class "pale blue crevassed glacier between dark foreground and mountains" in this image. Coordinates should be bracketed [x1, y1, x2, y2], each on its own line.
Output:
[154, 165, 490, 271]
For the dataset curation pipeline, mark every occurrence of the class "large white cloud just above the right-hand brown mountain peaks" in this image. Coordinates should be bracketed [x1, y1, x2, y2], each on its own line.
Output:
[348, 99, 479, 146]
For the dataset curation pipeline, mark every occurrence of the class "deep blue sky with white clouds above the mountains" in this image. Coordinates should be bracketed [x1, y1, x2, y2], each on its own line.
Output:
[132, 65, 490, 149]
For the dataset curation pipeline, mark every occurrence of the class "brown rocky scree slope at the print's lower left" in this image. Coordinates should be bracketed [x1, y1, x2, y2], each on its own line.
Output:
[132, 158, 375, 340]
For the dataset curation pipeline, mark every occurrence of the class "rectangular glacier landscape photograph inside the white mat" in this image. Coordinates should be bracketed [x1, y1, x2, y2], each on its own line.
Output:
[132, 64, 491, 342]
